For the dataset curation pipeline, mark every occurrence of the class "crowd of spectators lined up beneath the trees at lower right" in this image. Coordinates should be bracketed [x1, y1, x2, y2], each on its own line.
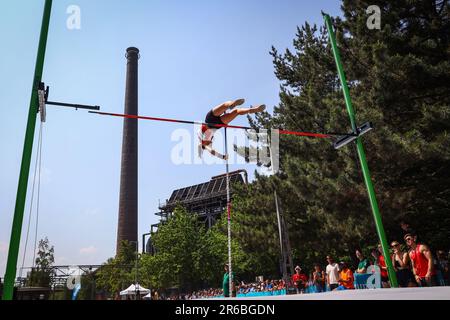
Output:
[156, 223, 450, 300]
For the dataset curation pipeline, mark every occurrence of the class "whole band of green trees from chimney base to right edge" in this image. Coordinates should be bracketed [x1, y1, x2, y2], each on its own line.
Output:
[96, 0, 450, 292]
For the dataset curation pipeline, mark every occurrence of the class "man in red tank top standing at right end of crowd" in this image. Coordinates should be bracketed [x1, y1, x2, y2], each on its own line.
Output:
[404, 233, 437, 287]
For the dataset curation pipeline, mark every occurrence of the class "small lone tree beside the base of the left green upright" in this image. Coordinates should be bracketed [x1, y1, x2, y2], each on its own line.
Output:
[27, 237, 55, 288]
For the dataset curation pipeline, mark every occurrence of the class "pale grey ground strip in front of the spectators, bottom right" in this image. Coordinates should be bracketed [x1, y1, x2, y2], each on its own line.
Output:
[227, 287, 450, 300]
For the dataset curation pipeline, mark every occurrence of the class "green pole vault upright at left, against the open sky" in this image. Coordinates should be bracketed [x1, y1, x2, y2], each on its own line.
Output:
[3, 0, 52, 300]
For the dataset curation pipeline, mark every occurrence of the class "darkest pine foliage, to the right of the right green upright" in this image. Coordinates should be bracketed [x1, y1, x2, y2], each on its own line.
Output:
[336, 0, 450, 248]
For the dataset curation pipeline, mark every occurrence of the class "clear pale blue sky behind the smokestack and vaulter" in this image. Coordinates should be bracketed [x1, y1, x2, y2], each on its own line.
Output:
[0, 0, 340, 276]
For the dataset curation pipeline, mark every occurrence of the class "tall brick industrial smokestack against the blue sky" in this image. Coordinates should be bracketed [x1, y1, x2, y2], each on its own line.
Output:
[116, 47, 140, 254]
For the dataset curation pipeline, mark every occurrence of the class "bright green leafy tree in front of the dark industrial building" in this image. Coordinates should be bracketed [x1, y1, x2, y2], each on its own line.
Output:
[140, 207, 246, 292]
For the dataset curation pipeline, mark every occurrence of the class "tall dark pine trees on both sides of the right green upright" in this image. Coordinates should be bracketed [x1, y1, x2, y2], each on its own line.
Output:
[232, 0, 450, 272]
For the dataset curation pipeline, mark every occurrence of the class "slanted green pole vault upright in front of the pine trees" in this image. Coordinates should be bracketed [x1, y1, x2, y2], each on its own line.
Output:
[323, 14, 398, 288]
